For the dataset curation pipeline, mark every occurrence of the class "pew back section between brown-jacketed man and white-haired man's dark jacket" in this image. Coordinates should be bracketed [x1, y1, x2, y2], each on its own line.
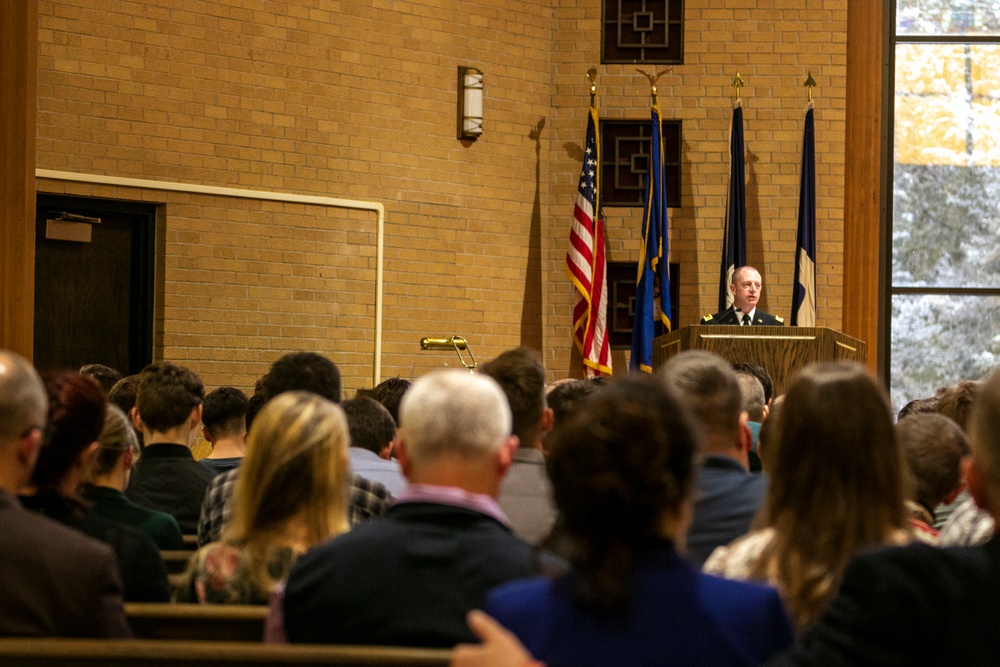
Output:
[125, 602, 267, 642]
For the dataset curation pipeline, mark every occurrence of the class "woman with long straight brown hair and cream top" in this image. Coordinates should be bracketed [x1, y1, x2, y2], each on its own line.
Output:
[705, 364, 910, 631]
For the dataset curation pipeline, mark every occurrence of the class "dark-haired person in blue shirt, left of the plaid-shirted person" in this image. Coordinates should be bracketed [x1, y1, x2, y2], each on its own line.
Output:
[200, 387, 250, 475]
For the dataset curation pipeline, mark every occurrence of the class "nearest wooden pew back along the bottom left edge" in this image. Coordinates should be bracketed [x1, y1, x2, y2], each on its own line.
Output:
[0, 637, 451, 667]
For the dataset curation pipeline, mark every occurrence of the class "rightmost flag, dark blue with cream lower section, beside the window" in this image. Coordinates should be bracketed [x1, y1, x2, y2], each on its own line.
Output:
[792, 102, 816, 327]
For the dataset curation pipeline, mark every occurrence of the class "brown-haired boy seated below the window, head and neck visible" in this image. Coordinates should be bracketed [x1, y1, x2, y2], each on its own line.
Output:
[896, 413, 970, 544]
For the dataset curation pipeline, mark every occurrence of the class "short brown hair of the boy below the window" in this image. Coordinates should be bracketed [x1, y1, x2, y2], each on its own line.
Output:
[896, 414, 970, 513]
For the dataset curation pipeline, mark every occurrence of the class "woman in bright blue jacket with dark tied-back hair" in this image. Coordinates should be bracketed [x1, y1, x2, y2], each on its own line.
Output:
[486, 379, 793, 667]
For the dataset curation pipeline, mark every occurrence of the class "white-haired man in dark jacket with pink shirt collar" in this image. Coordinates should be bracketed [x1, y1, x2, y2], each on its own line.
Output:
[283, 370, 537, 647]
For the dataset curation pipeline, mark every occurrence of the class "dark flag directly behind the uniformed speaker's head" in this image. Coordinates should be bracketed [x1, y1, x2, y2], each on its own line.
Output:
[719, 101, 747, 310]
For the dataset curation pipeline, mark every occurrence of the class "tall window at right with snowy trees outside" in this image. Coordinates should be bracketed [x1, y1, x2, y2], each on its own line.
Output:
[889, 0, 1000, 409]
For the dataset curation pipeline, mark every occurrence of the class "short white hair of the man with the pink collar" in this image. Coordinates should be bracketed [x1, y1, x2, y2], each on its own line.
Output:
[399, 370, 511, 462]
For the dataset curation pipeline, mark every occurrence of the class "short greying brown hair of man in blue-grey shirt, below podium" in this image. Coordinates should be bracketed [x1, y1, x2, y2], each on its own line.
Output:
[660, 350, 743, 438]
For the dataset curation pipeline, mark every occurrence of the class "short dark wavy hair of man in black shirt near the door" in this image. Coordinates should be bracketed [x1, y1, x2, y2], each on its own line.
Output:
[135, 361, 205, 433]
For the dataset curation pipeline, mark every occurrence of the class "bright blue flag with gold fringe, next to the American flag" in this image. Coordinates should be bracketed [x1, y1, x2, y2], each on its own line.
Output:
[629, 104, 670, 373]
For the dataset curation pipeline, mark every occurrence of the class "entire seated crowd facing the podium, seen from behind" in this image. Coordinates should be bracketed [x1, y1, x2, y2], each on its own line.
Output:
[0, 348, 1000, 667]
